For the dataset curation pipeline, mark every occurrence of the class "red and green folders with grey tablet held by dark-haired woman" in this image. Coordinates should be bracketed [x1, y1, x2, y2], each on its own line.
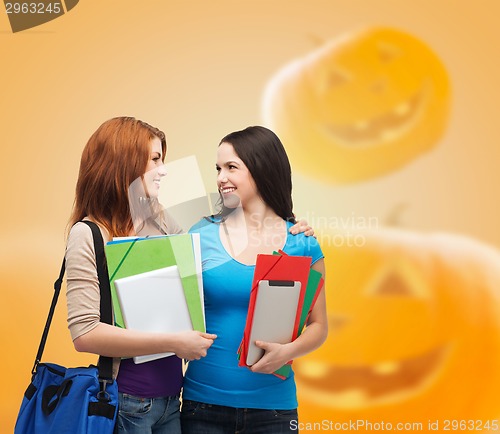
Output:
[238, 250, 323, 379]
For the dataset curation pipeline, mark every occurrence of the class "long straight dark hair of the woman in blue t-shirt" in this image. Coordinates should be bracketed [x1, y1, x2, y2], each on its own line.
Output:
[214, 126, 295, 223]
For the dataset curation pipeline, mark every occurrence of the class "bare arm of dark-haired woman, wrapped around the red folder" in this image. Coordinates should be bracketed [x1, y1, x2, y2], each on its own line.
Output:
[250, 259, 328, 374]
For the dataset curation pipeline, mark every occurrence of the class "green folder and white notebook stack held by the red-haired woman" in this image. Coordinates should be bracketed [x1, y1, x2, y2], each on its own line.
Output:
[105, 234, 205, 363]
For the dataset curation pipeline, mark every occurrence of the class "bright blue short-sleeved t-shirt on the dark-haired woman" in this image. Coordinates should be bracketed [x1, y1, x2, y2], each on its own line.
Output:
[182, 220, 323, 410]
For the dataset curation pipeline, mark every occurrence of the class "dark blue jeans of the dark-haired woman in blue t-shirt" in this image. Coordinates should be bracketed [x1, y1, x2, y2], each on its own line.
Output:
[181, 400, 298, 434]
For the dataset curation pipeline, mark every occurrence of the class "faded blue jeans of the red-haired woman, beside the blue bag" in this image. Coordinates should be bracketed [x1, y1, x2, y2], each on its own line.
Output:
[115, 393, 181, 434]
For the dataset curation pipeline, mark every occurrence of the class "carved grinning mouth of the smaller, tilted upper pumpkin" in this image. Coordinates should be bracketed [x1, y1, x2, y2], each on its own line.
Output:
[323, 86, 425, 147]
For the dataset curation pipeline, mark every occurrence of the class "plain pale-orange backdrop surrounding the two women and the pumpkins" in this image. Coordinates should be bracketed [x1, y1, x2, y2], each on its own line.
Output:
[0, 0, 500, 433]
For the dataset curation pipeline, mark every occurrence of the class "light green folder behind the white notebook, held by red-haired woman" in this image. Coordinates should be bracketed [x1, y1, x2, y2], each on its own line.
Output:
[104, 234, 205, 332]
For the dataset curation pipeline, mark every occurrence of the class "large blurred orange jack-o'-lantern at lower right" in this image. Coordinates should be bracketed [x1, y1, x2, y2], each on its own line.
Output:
[293, 231, 500, 428]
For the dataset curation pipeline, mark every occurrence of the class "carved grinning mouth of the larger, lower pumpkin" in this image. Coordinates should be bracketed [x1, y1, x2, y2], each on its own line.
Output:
[294, 346, 449, 408]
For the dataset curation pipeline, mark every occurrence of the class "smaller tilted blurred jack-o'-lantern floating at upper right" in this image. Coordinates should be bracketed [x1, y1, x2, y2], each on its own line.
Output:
[264, 28, 450, 182]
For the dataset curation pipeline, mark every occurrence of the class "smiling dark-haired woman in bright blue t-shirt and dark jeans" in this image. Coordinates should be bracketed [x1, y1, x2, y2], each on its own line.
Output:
[181, 127, 328, 434]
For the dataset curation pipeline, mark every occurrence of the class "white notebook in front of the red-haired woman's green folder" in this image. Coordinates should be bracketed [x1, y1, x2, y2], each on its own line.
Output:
[115, 265, 193, 363]
